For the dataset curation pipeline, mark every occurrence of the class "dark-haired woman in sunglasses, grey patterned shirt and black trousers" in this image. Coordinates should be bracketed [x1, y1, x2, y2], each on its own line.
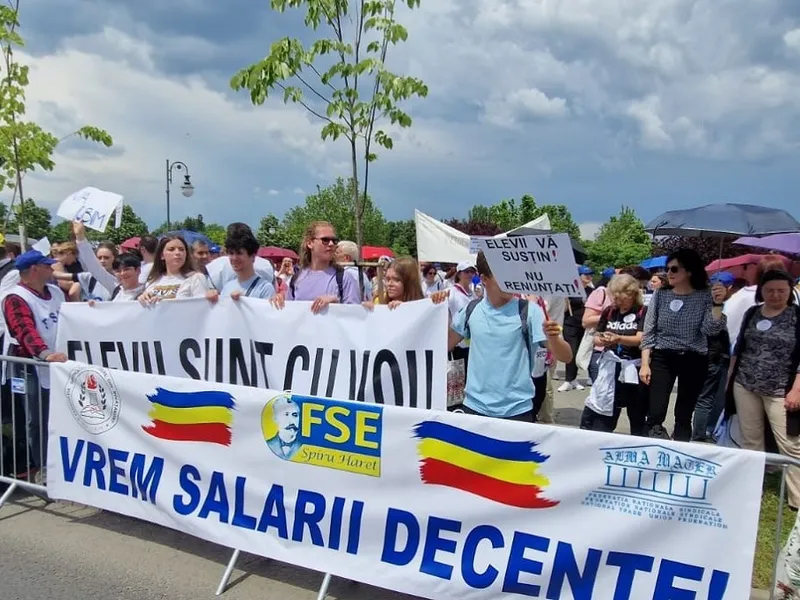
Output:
[639, 248, 727, 442]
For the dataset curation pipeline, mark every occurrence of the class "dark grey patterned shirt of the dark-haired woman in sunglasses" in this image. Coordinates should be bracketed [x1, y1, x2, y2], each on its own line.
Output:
[642, 289, 725, 354]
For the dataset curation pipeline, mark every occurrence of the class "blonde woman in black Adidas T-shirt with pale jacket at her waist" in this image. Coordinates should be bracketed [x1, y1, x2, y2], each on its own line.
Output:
[581, 275, 648, 436]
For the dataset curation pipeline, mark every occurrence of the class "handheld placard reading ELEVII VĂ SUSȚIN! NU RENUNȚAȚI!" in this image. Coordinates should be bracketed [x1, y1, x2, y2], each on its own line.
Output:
[478, 233, 585, 298]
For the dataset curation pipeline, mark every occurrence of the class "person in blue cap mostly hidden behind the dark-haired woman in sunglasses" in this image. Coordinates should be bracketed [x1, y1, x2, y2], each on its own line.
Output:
[692, 271, 736, 442]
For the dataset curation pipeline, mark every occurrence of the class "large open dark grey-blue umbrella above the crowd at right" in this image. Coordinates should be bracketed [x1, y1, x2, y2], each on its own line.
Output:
[645, 204, 800, 237]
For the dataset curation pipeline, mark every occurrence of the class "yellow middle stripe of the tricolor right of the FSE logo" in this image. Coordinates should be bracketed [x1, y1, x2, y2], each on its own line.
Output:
[418, 438, 550, 488]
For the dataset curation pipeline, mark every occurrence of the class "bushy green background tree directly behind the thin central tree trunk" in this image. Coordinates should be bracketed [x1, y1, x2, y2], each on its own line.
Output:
[283, 177, 387, 248]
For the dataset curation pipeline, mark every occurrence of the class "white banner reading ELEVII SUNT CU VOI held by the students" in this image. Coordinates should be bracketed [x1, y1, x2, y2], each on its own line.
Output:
[57, 297, 447, 410]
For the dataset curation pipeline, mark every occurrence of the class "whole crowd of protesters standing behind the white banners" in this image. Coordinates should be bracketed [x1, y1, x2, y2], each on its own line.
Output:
[0, 222, 800, 507]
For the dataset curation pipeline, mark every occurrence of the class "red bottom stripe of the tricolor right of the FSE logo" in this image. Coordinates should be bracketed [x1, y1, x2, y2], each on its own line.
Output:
[420, 458, 558, 508]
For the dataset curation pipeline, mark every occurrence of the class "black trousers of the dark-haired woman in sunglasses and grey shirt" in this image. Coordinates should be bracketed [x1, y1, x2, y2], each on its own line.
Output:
[647, 349, 708, 442]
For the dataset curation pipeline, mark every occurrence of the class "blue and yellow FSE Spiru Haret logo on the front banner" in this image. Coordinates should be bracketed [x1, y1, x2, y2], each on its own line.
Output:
[261, 392, 383, 477]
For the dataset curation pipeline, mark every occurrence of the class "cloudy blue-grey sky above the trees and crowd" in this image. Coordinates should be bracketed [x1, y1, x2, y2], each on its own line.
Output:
[10, 0, 800, 237]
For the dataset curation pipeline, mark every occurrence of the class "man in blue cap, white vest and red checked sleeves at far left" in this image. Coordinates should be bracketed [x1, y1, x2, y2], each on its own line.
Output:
[3, 250, 67, 482]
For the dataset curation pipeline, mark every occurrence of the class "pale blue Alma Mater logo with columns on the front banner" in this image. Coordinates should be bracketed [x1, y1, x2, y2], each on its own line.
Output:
[583, 444, 728, 529]
